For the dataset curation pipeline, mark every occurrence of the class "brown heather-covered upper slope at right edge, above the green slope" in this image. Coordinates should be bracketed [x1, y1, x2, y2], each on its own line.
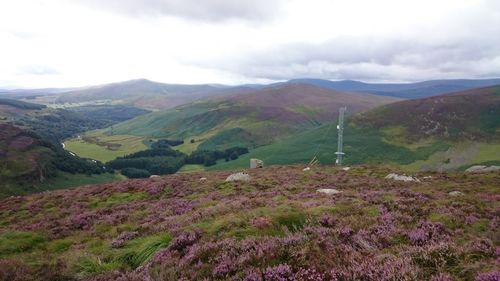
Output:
[354, 86, 500, 140]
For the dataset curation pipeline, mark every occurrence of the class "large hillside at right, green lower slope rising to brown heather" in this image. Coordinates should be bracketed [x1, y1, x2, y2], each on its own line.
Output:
[215, 86, 500, 171]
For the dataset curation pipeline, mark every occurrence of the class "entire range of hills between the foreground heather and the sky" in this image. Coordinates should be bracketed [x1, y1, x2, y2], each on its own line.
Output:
[0, 75, 500, 196]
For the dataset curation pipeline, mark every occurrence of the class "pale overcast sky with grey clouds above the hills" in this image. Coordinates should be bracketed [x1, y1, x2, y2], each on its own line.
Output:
[0, 0, 500, 88]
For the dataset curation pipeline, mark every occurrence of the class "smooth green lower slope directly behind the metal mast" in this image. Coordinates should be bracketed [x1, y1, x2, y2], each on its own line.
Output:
[208, 123, 449, 170]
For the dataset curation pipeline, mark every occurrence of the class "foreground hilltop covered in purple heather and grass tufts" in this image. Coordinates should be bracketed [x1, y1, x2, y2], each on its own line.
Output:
[0, 165, 500, 281]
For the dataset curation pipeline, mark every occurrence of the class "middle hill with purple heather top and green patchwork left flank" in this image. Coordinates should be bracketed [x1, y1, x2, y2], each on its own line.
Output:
[108, 83, 397, 149]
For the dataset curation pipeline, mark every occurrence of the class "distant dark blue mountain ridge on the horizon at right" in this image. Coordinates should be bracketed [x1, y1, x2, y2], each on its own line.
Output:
[290, 78, 500, 99]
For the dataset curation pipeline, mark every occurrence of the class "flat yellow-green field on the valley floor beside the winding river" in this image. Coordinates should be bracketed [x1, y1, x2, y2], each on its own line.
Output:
[64, 131, 147, 162]
